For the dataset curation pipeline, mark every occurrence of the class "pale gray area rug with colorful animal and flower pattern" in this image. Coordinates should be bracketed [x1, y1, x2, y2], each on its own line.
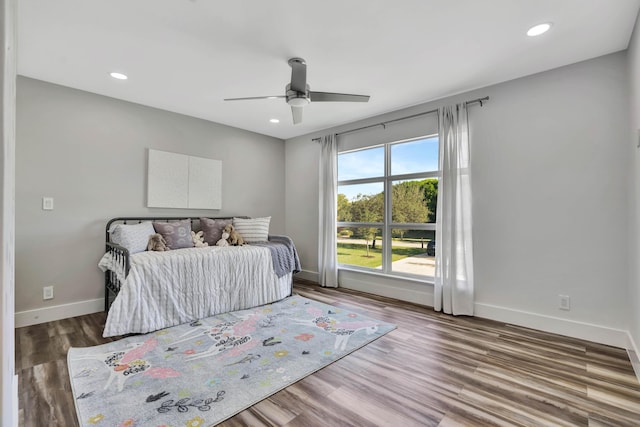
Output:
[67, 295, 395, 427]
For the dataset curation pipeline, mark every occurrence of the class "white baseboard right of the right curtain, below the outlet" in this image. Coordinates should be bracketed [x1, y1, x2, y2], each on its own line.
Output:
[474, 303, 630, 348]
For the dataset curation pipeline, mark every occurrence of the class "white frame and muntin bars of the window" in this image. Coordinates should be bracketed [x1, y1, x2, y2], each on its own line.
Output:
[336, 133, 440, 282]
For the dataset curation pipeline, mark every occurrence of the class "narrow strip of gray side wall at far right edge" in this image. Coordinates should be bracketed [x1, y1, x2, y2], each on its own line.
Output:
[628, 17, 640, 352]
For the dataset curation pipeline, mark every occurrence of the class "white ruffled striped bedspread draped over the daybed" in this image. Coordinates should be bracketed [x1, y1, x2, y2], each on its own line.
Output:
[99, 246, 291, 337]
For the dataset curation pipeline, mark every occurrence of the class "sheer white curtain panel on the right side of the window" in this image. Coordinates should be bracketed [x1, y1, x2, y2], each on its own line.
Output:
[433, 103, 473, 316]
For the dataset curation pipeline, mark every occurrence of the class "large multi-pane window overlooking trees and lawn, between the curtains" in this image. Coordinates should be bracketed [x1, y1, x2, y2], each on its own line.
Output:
[337, 136, 438, 279]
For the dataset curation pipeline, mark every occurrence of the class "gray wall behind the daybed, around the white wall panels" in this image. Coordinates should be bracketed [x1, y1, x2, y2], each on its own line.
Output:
[15, 77, 285, 312]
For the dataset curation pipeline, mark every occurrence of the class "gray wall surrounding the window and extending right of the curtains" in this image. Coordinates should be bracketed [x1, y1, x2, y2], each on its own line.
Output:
[286, 52, 637, 344]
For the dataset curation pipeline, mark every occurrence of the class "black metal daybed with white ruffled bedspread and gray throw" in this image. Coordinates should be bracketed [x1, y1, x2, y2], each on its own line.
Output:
[98, 217, 300, 337]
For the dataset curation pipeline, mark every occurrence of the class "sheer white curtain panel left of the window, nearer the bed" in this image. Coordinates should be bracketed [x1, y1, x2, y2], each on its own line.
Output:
[318, 135, 338, 288]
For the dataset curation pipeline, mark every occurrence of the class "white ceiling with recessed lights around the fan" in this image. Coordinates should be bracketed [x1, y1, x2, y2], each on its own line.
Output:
[17, 0, 640, 139]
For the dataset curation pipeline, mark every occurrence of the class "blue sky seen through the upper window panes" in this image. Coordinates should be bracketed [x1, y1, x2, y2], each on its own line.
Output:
[338, 137, 438, 200]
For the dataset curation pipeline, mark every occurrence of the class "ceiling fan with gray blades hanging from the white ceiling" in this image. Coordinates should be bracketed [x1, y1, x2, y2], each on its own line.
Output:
[225, 58, 369, 125]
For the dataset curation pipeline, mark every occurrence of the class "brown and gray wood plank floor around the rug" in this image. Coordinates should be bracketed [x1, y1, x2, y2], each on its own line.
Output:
[16, 280, 640, 427]
